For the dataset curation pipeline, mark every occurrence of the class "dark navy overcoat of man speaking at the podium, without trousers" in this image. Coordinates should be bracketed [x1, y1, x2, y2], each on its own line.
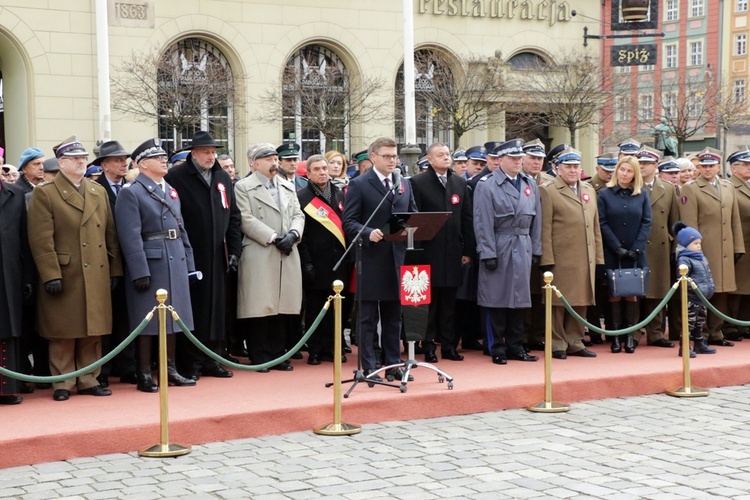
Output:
[344, 167, 417, 301]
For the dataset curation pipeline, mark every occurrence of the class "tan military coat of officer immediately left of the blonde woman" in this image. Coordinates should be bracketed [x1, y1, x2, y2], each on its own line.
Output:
[539, 177, 604, 306]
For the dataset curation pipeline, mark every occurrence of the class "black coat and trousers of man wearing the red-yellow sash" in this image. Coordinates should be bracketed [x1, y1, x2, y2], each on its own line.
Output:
[297, 182, 351, 355]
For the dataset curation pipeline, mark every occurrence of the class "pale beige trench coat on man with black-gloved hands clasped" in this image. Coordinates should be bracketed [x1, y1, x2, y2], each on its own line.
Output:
[234, 173, 305, 318]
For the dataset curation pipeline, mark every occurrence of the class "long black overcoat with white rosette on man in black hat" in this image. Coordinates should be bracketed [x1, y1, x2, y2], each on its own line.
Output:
[164, 155, 242, 341]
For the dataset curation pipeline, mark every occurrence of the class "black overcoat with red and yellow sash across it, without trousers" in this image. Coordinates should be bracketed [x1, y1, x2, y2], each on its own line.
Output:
[297, 182, 351, 290]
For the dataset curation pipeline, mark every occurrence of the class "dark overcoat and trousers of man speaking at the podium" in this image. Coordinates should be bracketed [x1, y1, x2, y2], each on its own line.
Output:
[344, 168, 417, 371]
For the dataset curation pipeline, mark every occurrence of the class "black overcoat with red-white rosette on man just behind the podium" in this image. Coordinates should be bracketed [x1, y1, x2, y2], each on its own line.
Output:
[409, 166, 476, 287]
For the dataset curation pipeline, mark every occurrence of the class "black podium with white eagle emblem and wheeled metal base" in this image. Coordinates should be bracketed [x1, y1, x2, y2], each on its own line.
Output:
[370, 212, 453, 393]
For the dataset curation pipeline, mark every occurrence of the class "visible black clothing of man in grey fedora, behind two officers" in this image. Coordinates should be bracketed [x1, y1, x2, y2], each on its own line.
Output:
[94, 174, 135, 376]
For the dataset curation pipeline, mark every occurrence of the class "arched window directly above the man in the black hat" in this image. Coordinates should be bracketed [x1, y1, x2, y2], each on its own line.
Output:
[157, 38, 235, 153]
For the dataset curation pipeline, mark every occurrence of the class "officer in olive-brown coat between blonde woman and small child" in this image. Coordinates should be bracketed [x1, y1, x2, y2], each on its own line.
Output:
[636, 146, 680, 348]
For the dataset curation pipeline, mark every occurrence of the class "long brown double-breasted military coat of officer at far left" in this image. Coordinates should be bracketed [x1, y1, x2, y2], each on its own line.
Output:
[28, 173, 122, 339]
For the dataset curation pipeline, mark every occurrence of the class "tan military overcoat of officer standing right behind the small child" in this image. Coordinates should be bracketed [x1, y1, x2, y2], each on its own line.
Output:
[680, 177, 745, 293]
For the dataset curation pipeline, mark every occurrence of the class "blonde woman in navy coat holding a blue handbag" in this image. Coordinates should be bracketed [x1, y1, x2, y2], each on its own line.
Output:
[597, 156, 651, 353]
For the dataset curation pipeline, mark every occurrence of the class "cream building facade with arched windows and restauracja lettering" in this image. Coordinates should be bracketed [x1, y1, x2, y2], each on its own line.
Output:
[0, 0, 600, 172]
